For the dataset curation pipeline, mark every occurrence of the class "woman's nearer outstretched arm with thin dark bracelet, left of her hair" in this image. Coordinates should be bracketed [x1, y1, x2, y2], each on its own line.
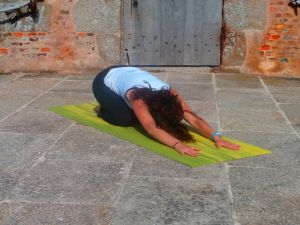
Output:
[127, 90, 200, 157]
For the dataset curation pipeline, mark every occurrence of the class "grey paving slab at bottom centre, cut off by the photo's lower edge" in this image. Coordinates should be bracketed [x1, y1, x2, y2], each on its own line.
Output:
[111, 177, 232, 225]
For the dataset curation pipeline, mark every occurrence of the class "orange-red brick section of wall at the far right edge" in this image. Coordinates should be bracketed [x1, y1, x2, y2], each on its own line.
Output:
[241, 0, 300, 77]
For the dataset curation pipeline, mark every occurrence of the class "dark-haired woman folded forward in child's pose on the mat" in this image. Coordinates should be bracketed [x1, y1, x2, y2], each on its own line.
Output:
[93, 66, 239, 157]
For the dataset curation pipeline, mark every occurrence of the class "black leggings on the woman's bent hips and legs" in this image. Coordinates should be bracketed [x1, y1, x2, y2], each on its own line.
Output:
[93, 65, 138, 127]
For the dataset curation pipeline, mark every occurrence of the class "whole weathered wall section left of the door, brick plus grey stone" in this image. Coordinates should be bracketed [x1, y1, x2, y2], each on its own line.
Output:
[0, 0, 121, 72]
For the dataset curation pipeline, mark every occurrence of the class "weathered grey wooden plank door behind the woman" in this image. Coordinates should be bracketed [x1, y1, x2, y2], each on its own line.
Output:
[121, 0, 223, 66]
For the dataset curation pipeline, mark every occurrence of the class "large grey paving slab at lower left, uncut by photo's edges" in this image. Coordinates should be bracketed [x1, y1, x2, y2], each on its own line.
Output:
[11, 160, 121, 205]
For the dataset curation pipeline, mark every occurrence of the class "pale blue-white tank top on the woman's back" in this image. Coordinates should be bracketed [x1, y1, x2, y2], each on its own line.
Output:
[104, 67, 170, 108]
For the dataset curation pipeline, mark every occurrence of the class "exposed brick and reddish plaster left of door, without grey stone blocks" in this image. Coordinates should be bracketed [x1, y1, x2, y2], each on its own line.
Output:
[0, 0, 118, 72]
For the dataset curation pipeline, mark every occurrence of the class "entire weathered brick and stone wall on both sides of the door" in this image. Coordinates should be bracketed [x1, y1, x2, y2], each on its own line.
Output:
[0, 0, 300, 76]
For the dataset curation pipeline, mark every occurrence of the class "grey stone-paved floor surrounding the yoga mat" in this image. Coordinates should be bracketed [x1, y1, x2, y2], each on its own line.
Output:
[0, 68, 300, 225]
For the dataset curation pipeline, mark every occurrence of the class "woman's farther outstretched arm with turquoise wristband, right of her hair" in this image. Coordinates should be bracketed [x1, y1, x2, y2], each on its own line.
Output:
[171, 89, 240, 150]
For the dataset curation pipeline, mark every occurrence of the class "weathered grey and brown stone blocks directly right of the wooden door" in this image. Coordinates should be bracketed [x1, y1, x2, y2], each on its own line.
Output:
[222, 0, 269, 69]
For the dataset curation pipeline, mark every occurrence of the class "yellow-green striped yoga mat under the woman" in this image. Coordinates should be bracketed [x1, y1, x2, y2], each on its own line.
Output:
[49, 103, 271, 167]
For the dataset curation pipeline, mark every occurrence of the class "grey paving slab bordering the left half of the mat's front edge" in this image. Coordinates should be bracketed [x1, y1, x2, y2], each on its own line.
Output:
[45, 125, 137, 162]
